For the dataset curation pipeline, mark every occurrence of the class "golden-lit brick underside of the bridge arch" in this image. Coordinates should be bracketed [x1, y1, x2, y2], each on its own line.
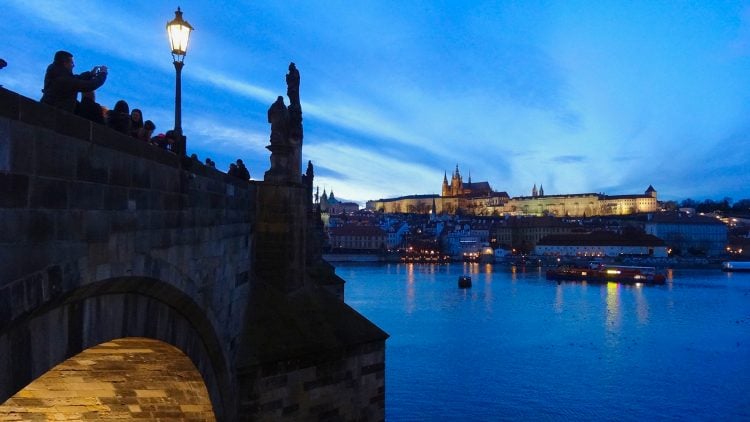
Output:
[0, 337, 215, 421]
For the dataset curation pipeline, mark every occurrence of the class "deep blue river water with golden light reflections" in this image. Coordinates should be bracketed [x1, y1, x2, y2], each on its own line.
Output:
[336, 263, 750, 421]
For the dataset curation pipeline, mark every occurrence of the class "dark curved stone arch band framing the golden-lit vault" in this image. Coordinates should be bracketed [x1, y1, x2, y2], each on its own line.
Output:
[0, 276, 236, 420]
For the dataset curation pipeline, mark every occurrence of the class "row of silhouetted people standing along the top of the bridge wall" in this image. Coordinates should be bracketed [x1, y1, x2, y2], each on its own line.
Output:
[33, 51, 250, 180]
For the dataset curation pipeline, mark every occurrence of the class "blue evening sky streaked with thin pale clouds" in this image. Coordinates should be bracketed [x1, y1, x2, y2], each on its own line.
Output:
[0, 0, 750, 205]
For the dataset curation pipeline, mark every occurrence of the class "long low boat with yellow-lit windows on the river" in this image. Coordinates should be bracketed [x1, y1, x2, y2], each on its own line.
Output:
[547, 265, 666, 284]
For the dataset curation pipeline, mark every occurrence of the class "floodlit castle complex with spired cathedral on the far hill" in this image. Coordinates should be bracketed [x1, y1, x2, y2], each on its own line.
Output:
[367, 165, 659, 217]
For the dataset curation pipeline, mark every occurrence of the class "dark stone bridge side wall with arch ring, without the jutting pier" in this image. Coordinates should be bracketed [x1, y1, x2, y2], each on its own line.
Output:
[0, 89, 256, 415]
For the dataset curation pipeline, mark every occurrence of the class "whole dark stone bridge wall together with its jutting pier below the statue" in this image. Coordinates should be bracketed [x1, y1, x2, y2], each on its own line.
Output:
[0, 88, 387, 421]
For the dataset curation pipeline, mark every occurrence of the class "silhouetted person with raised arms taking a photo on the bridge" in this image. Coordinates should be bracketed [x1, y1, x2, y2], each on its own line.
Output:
[41, 51, 107, 113]
